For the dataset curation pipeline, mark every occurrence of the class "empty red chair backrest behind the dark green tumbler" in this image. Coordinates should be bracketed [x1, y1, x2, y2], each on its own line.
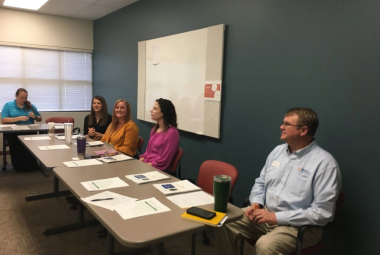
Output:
[197, 160, 239, 196]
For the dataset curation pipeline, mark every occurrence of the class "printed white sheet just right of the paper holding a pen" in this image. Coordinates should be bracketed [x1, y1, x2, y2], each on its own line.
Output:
[116, 197, 170, 220]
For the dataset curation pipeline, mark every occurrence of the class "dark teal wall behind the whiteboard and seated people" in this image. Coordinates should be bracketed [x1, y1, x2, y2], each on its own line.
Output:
[93, 0, 380, 254]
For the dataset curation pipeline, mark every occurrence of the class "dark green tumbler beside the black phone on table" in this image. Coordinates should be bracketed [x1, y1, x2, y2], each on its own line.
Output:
[214, 175, 231, 213]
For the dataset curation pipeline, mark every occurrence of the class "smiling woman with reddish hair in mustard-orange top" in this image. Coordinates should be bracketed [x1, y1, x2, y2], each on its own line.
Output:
[101, 99, 139, 157]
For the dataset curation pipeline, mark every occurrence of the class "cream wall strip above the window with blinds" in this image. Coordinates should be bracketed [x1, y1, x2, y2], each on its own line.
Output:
[0, 8, 94, 52]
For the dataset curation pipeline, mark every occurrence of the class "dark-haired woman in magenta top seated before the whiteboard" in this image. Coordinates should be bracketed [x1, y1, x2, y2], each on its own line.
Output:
[140, 98, 179, 170]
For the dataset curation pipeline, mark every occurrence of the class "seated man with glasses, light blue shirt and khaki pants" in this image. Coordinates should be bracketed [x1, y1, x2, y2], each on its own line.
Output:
[216, 108, 341, 255]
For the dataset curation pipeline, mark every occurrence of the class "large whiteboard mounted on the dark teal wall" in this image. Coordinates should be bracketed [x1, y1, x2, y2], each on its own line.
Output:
[137, 25, 224, 138]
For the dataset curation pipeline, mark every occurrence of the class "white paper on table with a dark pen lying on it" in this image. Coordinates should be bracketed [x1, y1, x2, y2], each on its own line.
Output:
[81, 190, 137, 211]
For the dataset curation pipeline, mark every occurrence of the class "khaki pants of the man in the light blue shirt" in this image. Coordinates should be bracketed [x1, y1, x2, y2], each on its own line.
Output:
[215, 207, 323, 255]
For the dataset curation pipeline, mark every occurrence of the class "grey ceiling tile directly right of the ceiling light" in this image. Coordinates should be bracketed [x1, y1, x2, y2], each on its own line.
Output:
[38, 0, 89, 16]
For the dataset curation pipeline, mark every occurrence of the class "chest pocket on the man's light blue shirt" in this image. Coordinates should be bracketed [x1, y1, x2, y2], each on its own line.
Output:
[287, 169, 312, 196]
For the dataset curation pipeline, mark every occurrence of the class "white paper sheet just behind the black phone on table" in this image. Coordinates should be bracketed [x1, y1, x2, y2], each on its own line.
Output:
[167, 191, 214, 209]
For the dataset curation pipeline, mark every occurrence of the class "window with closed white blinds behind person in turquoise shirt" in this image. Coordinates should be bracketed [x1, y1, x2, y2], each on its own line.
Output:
[0, 46, 92, 111]
